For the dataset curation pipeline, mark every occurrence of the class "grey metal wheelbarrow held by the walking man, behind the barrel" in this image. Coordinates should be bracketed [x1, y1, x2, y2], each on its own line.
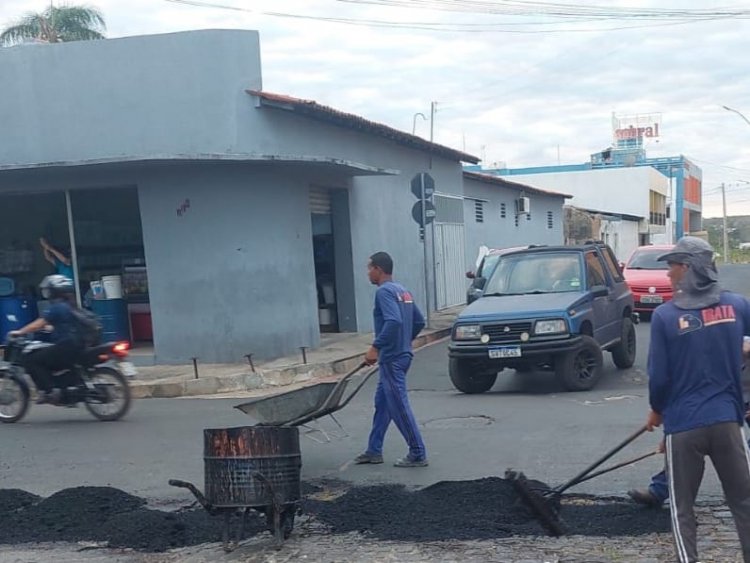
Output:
[235, 362, 377, 426]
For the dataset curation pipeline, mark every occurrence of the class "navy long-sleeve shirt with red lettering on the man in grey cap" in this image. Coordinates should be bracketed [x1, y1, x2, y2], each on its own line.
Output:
[648, 291, 750, 434]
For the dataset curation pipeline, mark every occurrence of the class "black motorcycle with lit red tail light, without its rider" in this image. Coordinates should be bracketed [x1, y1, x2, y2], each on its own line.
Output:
[0, 336, 135, 423]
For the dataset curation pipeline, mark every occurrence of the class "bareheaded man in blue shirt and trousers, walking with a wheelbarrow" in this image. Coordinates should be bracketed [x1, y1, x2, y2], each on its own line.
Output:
[354, 252, 427, 467]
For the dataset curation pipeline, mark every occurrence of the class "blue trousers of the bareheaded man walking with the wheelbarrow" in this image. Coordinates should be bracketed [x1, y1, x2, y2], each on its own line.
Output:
[367, 354, 427, 460]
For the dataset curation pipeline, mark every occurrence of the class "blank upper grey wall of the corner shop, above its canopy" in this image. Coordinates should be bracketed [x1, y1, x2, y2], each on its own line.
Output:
[0, 30, 261, 165]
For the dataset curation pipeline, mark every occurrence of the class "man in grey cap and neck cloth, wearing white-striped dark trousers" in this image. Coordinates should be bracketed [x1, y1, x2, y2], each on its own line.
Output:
[646, 236, 750, 563]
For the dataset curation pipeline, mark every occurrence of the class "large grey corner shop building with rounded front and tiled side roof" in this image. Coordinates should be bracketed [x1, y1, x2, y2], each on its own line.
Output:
[0, 30, 564, 363]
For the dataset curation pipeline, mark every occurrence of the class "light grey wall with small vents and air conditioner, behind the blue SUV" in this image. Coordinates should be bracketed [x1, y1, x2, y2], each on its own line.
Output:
[464, 179, 564, 270]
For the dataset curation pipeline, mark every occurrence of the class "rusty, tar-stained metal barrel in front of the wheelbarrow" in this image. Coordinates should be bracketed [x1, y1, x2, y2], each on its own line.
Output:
[203, 426, 302, 508]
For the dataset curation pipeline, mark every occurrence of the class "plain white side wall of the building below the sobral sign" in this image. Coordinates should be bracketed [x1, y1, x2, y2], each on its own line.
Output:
[503, 166, 669, 220]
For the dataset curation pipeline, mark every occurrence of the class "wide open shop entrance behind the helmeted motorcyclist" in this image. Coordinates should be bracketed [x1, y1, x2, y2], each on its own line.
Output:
[0, 186, 153, 348]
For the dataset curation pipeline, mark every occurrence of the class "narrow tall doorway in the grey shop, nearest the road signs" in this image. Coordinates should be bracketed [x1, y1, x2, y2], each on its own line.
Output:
[310, 186, 357, 333]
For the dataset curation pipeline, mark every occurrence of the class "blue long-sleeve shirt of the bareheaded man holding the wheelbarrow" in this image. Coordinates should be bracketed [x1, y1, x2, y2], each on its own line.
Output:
[372, 281, 425, 363]
